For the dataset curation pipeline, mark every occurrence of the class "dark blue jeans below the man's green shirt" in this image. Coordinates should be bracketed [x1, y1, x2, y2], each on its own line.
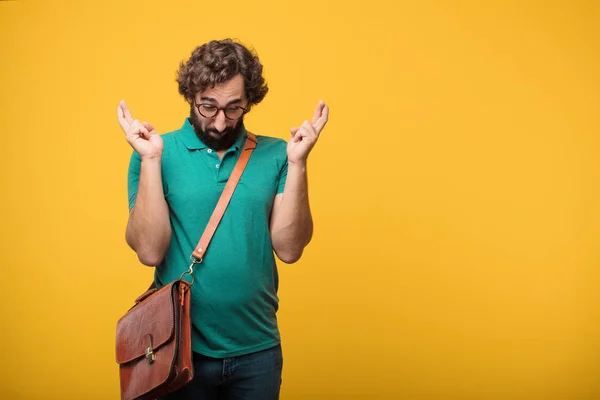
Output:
[163, 345, 283, 400]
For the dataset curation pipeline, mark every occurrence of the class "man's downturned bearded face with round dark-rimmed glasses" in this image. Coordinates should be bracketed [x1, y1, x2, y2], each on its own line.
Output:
[190, 75, 248, 151]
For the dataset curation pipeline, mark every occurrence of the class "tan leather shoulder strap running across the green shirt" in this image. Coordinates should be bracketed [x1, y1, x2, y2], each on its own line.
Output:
[192, 132, 257, 265]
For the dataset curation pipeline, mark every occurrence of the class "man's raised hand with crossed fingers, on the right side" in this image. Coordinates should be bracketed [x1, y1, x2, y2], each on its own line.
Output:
[287, 100, 329, 164]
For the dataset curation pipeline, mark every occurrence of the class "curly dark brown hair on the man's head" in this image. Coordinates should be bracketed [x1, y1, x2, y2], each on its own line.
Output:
[177, 39, 269, 109]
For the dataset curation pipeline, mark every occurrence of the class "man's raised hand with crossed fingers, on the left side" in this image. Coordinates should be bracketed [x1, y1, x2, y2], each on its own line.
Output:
[117, 100, 164, 158]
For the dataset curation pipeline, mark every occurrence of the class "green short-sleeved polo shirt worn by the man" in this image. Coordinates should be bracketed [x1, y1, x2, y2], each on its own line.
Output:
[128, 119, 287, 358]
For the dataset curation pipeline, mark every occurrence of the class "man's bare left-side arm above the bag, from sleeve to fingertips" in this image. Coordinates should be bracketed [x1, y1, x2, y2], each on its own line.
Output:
[117, 101, 171, 266]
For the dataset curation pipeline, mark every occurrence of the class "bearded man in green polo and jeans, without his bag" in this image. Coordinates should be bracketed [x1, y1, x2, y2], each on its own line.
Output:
[117, 39, 329, 400]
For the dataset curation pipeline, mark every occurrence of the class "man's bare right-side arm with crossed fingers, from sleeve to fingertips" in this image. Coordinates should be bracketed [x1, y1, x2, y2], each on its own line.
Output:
[270, 101, 329, 263]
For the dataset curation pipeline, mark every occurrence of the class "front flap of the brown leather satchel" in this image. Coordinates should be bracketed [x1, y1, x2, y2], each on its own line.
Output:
[117, 282, 176, 364]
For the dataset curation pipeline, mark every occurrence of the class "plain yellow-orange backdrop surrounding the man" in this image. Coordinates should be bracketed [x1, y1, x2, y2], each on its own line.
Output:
[0, 0, 600, 400]
